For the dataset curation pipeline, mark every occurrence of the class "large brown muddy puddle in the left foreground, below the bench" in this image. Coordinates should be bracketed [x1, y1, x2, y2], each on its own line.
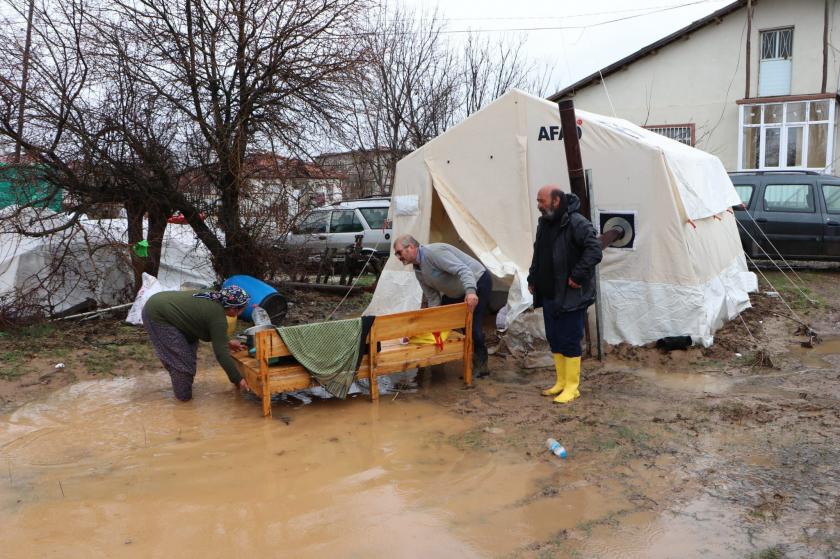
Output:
[0, 372, 626, 557]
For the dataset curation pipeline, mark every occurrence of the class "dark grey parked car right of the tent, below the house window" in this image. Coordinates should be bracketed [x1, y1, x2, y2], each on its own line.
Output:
[729, 171, 840, 260]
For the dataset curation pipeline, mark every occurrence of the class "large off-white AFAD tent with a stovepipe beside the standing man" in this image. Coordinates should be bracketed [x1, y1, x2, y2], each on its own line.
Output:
[367, 90, 757, 345]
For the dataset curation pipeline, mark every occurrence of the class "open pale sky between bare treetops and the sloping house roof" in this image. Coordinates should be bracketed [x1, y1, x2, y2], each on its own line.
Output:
[400, 0, 733, 93]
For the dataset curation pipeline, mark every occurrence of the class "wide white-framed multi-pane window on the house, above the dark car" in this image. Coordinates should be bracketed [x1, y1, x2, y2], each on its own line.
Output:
[739, 99, 834, 171]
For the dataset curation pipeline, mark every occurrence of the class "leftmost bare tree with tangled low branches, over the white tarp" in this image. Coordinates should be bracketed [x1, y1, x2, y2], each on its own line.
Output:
[0, 1, 185, 294]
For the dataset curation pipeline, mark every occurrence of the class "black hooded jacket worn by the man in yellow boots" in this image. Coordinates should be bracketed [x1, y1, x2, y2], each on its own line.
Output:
[528, 194, 602, 312]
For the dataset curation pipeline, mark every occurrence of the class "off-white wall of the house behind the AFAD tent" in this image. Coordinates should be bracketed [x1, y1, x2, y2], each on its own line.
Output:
[556, 0, 840, 172]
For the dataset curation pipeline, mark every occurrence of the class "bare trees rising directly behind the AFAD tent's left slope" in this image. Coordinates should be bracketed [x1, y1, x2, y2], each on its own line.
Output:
[342, 7, 549, 195]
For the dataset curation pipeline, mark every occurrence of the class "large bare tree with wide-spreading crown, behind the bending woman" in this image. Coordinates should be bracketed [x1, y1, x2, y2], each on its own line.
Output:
[103, 0, 363, 275]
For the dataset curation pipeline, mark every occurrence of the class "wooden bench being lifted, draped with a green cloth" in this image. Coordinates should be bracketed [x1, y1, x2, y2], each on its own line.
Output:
[233, 303, 473, 416]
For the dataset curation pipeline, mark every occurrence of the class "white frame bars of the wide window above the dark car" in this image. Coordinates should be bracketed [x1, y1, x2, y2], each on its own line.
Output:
[737, 98, 837, 174]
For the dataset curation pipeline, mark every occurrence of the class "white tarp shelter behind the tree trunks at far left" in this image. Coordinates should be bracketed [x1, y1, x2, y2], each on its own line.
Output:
[0, 208, 216, 313]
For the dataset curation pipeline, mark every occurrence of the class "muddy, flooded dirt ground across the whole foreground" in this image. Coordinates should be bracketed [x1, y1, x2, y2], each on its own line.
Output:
[0, 274, 840, 559]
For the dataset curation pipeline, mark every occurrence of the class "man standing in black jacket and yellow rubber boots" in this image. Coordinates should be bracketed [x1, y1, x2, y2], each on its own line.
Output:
[528, 185, 602, 404]
